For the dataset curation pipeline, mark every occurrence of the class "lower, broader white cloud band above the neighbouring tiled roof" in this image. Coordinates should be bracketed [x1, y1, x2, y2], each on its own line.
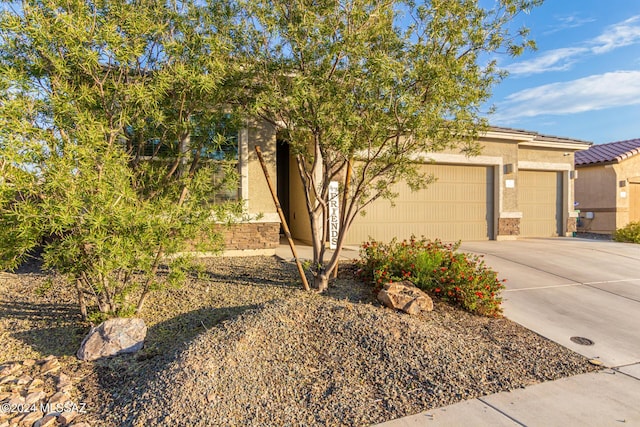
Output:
[492, 71, 640, 120]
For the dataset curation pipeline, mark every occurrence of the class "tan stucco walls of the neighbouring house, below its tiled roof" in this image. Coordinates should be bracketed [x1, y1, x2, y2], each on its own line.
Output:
[575, 155, 640, 234]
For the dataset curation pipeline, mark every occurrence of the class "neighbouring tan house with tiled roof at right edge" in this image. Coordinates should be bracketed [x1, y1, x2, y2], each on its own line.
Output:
[575, 139, 640, 234]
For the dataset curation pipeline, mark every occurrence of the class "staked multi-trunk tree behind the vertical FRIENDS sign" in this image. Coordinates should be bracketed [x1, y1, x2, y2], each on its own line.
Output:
[245, 0, 541, 291]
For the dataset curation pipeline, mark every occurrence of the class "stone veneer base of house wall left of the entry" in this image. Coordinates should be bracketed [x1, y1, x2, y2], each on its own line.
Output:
[222, 222, 280, 250]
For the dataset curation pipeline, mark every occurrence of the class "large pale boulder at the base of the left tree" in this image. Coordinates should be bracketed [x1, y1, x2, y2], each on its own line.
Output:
[77, 318, 147, 361]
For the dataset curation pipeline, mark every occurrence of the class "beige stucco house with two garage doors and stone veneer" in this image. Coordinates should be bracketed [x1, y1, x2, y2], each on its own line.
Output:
[225, 122, 591, 254]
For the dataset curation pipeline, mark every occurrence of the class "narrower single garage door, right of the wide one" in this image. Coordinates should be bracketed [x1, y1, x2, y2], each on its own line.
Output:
[518, 170, 562, 237]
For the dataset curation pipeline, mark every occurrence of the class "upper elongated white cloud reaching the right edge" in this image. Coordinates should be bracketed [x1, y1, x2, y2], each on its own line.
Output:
[505, 15, 640, 75]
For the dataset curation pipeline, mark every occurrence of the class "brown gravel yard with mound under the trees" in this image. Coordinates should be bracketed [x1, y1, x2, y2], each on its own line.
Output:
[0, 257, 596, 426]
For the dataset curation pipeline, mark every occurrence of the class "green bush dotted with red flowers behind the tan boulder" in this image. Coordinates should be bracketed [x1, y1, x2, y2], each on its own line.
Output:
[359, 237, 504, 317]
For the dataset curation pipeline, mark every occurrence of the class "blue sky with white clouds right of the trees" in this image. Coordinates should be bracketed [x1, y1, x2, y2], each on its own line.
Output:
[489, 0, 640, 144]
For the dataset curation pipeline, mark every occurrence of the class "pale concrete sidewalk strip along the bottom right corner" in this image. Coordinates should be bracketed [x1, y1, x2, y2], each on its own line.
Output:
[377, 364, 640, 427]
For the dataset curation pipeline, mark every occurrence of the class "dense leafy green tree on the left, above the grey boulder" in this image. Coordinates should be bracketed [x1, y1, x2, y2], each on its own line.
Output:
[0, 0, 241, 318]
